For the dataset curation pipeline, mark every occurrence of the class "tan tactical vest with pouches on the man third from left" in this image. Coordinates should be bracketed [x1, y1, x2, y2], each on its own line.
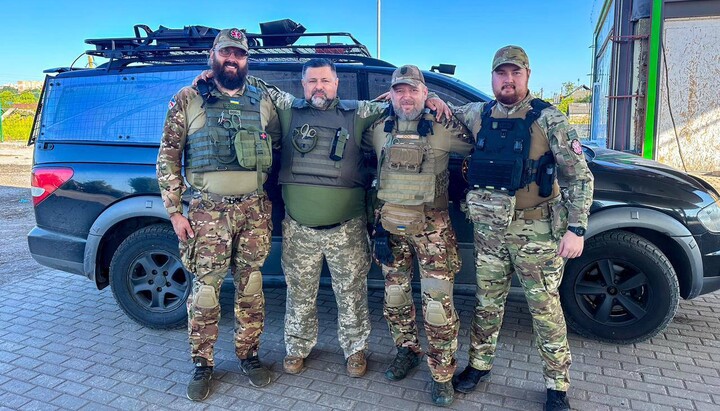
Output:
[377, 116, 438, 206]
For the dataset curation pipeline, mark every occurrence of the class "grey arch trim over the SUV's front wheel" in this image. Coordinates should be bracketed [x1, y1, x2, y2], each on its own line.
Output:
[585, 207, 703, 299]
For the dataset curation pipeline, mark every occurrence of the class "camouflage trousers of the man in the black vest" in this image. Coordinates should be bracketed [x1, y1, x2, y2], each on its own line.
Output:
[467, 191, 572, 391]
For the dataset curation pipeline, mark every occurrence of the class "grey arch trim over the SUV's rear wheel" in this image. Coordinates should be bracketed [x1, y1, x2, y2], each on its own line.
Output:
[83, 195, 170, 289]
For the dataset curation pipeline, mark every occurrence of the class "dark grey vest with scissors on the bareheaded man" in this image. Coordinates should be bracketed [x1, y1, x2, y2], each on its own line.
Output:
[278, 99, 367, 188]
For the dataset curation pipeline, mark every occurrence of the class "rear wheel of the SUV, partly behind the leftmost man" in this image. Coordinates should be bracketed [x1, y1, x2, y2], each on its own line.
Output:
[110, 224, 192, 329]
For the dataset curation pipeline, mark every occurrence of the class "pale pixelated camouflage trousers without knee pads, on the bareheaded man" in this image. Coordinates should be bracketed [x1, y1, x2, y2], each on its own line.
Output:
[282, 216, 370, 358]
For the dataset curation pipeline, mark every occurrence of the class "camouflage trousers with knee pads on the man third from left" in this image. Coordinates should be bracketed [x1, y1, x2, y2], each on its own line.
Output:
[382, 210, 460, 382]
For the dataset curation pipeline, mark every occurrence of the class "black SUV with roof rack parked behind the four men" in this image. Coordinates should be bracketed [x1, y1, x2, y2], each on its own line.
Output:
[28, 22, 720, 343]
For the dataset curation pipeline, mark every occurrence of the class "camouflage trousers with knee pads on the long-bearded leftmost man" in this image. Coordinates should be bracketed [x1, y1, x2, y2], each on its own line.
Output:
[180, 194, 272, 365]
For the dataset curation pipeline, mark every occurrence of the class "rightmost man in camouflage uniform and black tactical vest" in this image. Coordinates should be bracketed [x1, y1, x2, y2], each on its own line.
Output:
[453, 46, 593, 410]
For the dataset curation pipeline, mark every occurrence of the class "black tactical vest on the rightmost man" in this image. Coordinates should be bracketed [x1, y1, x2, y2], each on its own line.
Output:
[467, 99, 557, 197]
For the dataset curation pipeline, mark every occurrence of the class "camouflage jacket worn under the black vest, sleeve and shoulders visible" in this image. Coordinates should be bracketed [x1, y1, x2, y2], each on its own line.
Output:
[453, 93, 593, 227]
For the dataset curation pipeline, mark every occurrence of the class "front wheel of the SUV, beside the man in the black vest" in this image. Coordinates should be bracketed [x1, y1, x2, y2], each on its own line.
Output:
[560, 231, 680, 344]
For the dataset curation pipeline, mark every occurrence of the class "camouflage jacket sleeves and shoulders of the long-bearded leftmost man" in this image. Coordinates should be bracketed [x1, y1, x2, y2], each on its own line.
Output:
[157, 76, 281, 215]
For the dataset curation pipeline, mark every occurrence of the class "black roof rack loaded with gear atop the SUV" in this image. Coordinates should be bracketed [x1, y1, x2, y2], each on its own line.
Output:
[85, 19, 394, 68]
